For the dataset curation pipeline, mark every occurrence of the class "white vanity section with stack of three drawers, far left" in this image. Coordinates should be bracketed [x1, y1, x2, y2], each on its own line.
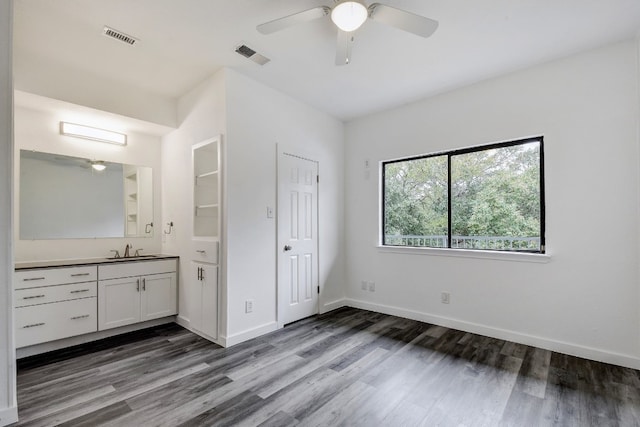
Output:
[13, 265, 97, 348]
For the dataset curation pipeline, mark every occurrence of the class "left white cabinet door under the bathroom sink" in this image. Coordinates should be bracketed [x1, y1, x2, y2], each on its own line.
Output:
[98, 277, 142, 331]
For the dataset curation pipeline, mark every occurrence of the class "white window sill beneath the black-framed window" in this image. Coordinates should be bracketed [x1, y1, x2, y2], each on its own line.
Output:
[378, 245, 551, 263]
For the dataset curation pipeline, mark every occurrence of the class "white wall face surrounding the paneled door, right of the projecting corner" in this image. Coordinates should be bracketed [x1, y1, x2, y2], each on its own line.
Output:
[226, 70, 344, 343]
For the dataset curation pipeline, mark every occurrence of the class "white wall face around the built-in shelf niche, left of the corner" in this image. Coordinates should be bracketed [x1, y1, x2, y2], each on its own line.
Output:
[162, 70, 226, 338]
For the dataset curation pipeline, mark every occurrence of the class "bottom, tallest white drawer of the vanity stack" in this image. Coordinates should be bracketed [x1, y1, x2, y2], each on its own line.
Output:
[15, 297, 98, 347]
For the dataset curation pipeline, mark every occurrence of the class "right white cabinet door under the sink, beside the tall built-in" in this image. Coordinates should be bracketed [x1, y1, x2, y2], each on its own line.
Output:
[140, 273, 178, 321]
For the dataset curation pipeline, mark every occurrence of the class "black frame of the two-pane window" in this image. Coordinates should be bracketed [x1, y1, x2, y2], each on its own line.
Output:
[379, 135, 546, 254]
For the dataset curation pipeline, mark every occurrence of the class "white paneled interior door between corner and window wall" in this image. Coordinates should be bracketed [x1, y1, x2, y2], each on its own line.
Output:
[278, 153, 319, 325]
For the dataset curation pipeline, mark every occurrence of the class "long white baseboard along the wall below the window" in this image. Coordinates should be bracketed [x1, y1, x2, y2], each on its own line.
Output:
[345, 298, 640, 369]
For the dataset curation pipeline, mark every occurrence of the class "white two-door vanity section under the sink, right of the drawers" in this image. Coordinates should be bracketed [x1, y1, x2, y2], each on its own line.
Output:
[98, 260, 178, 331]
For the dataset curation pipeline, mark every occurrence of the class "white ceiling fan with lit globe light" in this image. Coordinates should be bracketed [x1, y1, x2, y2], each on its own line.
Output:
[256, 0, 438, 65]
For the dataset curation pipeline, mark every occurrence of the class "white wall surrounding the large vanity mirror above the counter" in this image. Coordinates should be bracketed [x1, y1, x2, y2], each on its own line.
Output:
[13, 105, 162, 262]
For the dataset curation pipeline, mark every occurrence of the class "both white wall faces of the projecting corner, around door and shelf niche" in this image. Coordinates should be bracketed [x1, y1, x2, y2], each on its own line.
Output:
[163, 69, 344, 345]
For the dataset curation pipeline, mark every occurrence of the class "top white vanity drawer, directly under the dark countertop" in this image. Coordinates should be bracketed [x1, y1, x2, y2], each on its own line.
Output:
[14, 265, 98, 289]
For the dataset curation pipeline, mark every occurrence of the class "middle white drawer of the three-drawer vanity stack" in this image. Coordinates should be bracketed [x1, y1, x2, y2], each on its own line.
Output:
[13, 282, 98, 307]
